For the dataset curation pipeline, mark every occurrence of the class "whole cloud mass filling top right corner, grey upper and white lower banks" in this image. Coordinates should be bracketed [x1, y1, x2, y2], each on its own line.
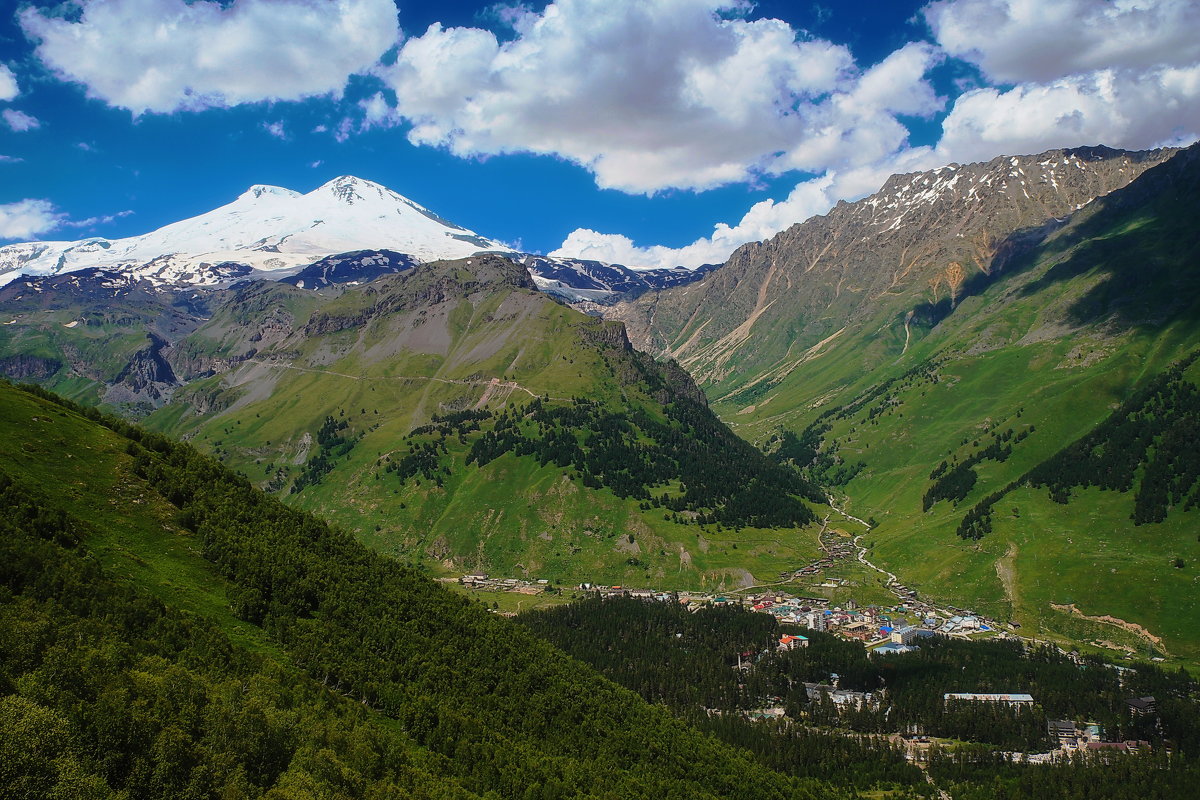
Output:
[925, 0, 1200, 161]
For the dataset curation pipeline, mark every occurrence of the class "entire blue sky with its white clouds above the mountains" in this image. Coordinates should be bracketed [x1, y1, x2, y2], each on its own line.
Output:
[0, 0, 1200, 266]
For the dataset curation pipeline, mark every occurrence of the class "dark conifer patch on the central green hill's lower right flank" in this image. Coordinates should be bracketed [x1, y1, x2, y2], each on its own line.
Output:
[380, 395, 823, 528]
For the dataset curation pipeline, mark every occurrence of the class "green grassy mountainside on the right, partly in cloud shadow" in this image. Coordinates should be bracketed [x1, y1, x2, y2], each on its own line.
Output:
[715, 142, 1200, 663]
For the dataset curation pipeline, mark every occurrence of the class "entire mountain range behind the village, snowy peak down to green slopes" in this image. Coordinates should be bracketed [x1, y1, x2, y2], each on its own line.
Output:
[7, 148, 1200, 664]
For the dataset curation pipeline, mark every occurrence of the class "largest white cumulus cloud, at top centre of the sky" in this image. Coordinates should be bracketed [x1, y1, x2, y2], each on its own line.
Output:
[377, 0, 941, 193]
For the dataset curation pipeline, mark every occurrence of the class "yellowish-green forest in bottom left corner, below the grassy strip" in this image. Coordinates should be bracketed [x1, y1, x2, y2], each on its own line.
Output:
[0, 473, 487, 800]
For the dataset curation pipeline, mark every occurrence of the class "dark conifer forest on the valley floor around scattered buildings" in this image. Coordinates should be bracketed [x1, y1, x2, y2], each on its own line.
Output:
[518, 597, 1200, 798]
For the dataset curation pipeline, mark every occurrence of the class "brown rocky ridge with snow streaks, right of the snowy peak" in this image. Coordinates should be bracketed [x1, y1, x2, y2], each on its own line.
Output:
[604, 148, 1176, 384]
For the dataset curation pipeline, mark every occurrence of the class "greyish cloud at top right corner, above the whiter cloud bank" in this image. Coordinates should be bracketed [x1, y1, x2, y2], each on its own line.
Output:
[925, 0, 1200, 83]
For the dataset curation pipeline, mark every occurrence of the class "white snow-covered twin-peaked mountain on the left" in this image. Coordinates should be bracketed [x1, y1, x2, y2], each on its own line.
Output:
[0, 175, 514, 285]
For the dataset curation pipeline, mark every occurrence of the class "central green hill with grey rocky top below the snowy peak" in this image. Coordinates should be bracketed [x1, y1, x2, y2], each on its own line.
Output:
[148, 257, 820, 588]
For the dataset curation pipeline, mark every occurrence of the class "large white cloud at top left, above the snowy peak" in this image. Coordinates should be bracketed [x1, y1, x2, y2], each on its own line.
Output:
[19, 0, 398, 114]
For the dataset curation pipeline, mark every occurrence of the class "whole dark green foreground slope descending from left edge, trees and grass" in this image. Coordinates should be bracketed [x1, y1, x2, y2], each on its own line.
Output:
[0, 385, 838, 798]
